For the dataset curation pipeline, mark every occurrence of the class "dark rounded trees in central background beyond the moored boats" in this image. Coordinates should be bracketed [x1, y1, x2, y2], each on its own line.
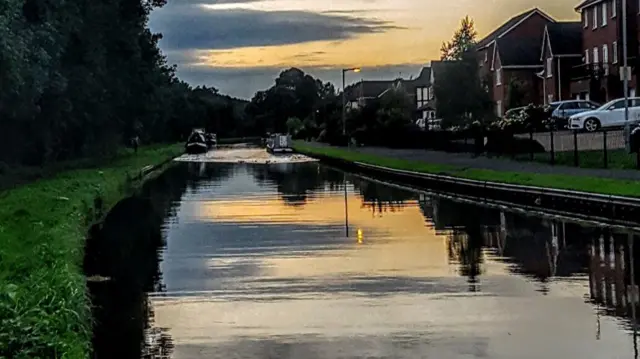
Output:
[246, 68, 418, 145]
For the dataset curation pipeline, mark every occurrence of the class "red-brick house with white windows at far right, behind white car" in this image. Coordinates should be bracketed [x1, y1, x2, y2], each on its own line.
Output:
[570, 0, 640, 103]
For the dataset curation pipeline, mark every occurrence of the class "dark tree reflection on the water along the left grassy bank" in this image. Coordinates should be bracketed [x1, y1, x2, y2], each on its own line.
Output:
[84, 166, 190, 359]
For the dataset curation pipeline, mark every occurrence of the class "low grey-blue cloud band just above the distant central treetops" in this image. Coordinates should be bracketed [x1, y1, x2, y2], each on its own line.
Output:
[178, 64, 421, 99]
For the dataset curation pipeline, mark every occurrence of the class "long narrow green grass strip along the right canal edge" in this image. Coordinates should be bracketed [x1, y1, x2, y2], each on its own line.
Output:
[294, 142, 640, 197]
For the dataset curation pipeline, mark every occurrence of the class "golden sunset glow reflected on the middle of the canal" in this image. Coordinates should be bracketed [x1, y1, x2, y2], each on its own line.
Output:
[188, 194, 505, 278]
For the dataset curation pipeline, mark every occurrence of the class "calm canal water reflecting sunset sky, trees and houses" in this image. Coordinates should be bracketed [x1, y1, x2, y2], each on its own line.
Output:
[85, 158, 639, 359]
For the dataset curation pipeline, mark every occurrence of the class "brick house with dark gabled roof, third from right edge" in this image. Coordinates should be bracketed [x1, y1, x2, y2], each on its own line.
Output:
[476, 8, 555, 117]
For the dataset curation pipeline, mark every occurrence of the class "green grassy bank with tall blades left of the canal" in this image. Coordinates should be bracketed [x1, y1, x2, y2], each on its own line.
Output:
[0, 145, 183, 359]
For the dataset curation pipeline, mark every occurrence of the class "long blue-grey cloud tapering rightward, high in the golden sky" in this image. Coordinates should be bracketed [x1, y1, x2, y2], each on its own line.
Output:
[150, 6, 398, 50]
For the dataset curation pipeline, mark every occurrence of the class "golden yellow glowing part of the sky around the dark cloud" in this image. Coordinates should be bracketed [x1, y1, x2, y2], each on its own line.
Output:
[196, 0, 577, 68]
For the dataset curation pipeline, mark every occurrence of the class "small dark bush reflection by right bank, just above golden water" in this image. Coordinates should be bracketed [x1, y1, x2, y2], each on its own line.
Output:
[353, 178, 417, 215]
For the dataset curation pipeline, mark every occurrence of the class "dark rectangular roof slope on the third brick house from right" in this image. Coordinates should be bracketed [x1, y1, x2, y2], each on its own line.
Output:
[496, 37, 542, 66]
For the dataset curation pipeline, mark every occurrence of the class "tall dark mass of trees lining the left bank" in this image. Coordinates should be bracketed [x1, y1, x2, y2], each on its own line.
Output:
[0, 0, 247, 167]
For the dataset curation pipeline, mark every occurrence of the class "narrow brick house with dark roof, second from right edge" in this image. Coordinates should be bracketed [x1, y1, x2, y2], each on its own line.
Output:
[540, 21, 583, 104]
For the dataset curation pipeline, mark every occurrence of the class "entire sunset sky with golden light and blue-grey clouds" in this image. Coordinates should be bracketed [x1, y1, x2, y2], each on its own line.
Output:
[150, 0, 579, 99]
